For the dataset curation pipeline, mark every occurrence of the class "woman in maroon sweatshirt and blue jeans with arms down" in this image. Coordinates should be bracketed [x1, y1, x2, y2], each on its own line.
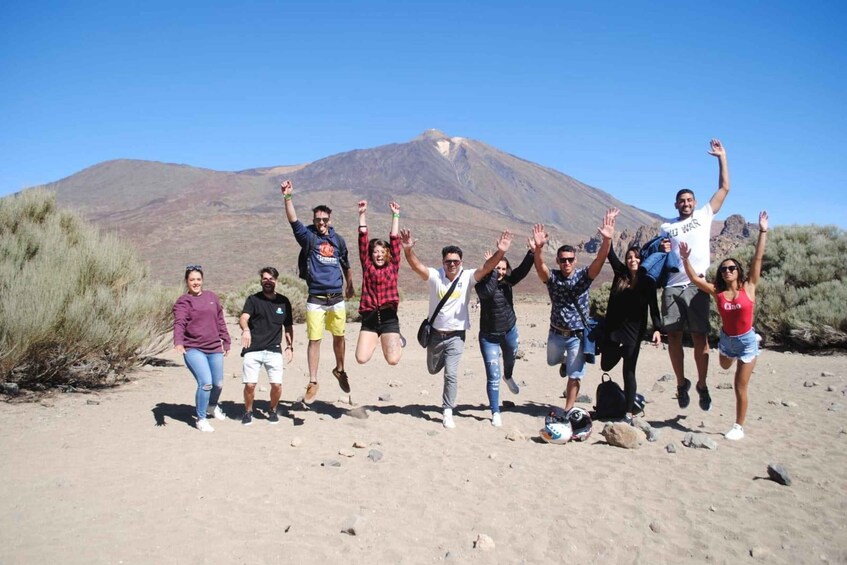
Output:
[174, 265, 231, 432]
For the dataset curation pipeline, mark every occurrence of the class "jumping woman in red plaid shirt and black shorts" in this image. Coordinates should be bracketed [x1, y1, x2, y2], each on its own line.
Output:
[356, 200, 403, 365]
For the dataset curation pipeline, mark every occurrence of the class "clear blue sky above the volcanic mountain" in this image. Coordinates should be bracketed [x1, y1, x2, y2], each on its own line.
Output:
[0, 0, 847, 227]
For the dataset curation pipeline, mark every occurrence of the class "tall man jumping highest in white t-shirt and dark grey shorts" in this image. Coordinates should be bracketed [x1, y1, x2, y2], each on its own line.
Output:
[660, 139, 729, 411]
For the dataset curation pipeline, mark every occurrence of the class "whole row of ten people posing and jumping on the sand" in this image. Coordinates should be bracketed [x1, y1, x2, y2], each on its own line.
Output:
[174, 139, 768, 440]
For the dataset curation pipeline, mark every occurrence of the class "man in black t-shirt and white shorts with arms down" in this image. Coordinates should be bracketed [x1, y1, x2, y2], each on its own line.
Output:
[238, 267, 294, 426]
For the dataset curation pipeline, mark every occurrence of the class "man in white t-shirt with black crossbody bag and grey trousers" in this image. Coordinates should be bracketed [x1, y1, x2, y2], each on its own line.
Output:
[400, 229, 512, 428]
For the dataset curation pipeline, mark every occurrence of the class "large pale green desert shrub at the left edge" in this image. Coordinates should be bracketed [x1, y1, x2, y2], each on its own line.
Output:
[0, 189, 178, 390]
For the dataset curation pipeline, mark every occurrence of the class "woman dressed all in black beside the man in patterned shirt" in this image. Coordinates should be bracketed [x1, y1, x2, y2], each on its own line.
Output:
[600, 246, 662, 424]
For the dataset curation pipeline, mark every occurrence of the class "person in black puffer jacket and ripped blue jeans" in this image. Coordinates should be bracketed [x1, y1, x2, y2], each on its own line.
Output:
[474, 245, 533, 427]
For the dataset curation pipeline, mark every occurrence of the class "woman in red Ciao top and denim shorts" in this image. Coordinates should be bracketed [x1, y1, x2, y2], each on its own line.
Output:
[679, 212, 768, 440]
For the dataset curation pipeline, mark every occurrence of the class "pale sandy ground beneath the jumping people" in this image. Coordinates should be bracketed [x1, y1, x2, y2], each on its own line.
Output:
[0, 302, 847, 563]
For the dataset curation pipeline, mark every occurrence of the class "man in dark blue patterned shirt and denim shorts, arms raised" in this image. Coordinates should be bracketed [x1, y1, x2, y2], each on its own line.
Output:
[530, 208, 620, 412]
